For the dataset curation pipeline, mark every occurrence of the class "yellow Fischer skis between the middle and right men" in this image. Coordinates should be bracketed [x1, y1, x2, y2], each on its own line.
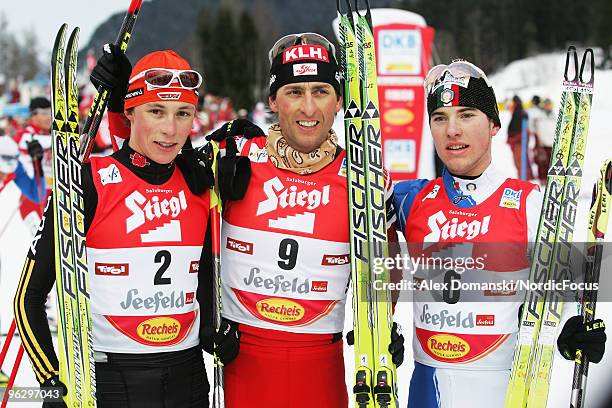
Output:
[336, 0, 398, 408]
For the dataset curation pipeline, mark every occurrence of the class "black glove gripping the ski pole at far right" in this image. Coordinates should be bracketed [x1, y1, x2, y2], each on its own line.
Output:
[557, 316, 606, 364]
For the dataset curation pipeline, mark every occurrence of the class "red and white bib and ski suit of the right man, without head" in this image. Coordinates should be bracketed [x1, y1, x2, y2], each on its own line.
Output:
[394, 166, 542, 407]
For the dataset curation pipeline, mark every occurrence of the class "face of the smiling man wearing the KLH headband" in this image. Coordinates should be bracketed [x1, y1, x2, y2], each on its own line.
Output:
[268, 82, 342, 153]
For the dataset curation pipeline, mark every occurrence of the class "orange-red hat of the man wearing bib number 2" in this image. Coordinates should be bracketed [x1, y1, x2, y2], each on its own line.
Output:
[125, 50, 198, 109]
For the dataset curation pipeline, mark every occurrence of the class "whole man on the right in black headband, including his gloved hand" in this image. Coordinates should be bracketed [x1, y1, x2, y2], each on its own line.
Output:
[394, 60, 605, 408]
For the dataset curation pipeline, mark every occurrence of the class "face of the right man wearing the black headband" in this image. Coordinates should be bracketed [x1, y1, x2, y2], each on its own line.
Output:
[429, 106, 499, 176]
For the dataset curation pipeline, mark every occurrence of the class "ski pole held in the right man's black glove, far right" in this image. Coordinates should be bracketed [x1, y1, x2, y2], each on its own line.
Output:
[570, 159, 612, 408]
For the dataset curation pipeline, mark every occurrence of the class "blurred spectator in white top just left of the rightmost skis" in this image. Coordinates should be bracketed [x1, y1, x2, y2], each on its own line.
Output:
[529, 98, 557, 185]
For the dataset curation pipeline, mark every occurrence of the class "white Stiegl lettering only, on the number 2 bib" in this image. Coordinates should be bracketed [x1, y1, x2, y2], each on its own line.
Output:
[125, 190, 187, 234]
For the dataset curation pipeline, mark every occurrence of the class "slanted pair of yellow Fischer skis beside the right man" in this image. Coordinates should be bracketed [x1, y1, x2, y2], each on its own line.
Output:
[504, 46, 595, 408]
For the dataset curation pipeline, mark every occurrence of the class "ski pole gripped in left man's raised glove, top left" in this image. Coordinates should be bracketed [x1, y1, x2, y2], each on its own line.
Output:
[79, 0, 142, 162]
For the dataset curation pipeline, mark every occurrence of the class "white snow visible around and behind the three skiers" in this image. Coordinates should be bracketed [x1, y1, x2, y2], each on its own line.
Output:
[0, 49, 612, 408]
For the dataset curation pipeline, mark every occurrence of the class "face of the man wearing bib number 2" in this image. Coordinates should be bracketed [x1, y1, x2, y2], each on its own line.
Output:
[126, 101, 195, 164]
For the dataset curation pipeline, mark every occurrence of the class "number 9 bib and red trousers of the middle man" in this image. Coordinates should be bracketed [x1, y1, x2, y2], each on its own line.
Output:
[221, 137, 395, 408]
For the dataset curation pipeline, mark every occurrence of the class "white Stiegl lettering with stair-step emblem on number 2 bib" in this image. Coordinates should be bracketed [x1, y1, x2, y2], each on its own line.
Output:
[125, 190, 187, 242]
